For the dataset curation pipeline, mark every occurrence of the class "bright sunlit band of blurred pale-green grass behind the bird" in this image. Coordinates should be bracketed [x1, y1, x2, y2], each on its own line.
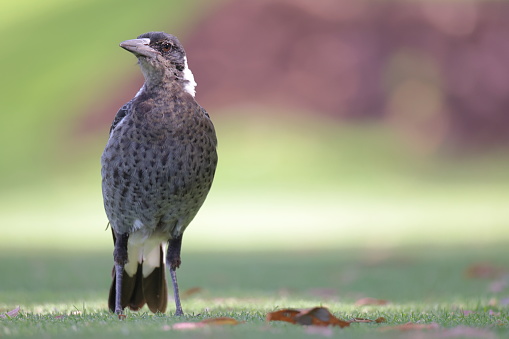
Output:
[0, 114, 509, 251]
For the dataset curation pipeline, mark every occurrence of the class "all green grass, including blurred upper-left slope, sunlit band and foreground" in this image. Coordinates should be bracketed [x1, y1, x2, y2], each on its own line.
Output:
[0, 0, 509, 338]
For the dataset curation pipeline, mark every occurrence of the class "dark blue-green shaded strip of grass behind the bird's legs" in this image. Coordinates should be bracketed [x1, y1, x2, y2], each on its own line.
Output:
[0, 245, 502, 308]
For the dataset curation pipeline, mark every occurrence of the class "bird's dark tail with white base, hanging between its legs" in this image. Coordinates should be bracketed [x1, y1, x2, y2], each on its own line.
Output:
[108, 244, 168, 313]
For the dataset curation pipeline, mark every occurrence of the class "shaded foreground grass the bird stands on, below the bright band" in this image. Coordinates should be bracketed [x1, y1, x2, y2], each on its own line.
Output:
[0, 246, 509, 338]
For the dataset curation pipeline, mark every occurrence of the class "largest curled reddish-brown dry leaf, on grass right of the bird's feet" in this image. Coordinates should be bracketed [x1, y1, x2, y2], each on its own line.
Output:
[266, 307, 350, 328]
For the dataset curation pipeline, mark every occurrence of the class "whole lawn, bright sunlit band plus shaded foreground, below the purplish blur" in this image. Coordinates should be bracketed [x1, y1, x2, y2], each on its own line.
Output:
[0, 117, 509, 338]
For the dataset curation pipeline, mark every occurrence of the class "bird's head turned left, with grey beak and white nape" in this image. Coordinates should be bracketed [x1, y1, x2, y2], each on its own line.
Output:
[120, 32, 196, 96]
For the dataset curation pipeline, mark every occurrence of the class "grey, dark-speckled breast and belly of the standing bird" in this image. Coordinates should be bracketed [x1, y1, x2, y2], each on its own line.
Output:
[101, 106, 217, 238]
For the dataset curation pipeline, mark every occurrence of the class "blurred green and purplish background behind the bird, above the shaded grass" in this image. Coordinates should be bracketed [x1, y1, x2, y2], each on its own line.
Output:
[0, 0, 509, 260]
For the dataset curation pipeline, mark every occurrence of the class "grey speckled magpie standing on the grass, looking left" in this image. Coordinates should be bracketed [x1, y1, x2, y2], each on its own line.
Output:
[101, 32, 218, 318]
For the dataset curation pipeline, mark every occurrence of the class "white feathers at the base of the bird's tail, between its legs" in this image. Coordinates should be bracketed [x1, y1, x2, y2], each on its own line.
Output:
[124, 228, 168, 277]
